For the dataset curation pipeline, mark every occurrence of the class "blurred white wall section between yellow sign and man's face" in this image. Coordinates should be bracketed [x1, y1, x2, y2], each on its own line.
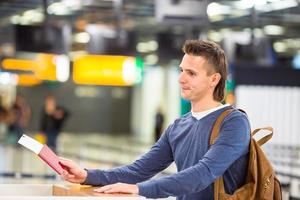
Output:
[131, 66, 180, 142]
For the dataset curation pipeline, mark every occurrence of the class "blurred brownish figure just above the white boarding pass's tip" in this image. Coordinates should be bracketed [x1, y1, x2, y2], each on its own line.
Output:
[8, 94, 31, 144]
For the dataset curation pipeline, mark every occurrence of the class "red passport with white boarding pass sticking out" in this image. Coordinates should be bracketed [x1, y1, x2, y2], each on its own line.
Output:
[18, 134, 63, 175]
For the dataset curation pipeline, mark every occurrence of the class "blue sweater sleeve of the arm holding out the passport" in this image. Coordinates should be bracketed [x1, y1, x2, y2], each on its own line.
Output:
[83, 128, 173, 185]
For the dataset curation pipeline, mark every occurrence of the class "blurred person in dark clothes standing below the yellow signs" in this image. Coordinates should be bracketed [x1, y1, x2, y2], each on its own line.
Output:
[40, 95, 69, 152]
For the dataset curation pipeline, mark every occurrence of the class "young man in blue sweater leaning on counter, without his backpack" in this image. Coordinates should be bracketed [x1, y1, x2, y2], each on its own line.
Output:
[61, 40, 250, 200]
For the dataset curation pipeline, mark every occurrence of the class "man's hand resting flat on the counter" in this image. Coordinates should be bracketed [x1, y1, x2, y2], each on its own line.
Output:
[94, 183, 139, 195]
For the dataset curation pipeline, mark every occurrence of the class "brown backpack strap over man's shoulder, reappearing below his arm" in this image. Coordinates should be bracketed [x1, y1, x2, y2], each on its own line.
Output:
[209, 108, 234, 200]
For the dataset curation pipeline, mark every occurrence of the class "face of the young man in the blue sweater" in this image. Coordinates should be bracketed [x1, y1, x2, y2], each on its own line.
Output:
[179, 54, 214, 103]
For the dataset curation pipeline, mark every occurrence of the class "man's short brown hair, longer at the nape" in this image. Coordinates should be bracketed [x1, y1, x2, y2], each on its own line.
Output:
[182, 40, 228, 101]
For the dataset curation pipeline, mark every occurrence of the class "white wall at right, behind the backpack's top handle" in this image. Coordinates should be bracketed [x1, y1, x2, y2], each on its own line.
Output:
[236, 86, 300, 146]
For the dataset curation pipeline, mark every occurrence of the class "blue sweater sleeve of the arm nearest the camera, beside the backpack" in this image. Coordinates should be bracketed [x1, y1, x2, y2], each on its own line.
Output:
[138, 113, 250, 198]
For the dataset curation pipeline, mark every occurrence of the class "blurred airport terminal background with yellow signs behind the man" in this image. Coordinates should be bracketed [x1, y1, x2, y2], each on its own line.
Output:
[0, 0, 300, 200]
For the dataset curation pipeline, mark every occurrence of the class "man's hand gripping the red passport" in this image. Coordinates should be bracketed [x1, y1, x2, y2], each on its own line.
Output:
[59, 158, 87, 183]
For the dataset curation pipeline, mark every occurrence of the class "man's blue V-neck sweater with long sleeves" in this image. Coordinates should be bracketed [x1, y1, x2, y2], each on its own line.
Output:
[84, 107, 250, 200]
